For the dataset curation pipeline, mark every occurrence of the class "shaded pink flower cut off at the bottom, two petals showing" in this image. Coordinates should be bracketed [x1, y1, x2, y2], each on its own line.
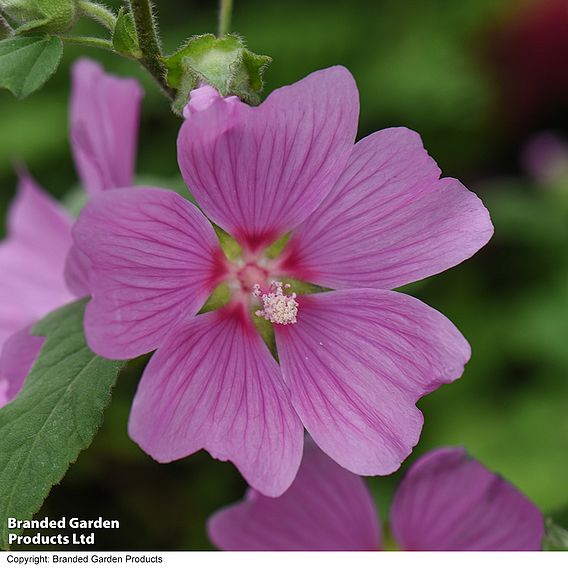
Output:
[208, 440, 544, 550]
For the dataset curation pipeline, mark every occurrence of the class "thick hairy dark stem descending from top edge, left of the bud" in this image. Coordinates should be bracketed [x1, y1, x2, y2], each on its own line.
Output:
[128, 0, 175, 101]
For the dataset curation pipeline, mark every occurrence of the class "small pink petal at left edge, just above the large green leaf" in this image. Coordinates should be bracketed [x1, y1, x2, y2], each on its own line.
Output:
[0, 325, 45, 408]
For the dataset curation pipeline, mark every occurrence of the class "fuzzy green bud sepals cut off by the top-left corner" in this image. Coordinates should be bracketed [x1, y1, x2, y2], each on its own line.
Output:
[0, 0, 79, 33]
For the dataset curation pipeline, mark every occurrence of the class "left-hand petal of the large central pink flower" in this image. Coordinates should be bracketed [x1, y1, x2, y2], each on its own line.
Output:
[73, 188, 224, 359]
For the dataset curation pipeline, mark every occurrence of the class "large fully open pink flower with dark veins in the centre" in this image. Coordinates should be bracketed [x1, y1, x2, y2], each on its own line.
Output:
[73, 67, 492, 496]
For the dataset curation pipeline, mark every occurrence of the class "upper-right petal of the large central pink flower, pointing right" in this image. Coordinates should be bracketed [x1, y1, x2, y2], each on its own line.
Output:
[282, 128, 493, 289]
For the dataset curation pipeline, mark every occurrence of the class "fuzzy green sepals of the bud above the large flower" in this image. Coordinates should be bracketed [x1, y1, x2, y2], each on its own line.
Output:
[164, 34, 272, 112]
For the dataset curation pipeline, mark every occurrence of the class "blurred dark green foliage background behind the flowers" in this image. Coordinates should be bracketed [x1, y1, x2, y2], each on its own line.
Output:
[0, 0, 568, 550]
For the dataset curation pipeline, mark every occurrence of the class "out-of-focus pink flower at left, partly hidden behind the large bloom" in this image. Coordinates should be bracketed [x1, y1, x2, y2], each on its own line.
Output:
[0, 59, 142, 407]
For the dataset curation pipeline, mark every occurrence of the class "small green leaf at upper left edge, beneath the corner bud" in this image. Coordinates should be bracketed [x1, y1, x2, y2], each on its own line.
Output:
[0, 35, 63, 99]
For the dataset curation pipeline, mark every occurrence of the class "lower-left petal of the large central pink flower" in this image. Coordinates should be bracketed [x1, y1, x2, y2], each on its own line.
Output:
[129, 306, 303, 496]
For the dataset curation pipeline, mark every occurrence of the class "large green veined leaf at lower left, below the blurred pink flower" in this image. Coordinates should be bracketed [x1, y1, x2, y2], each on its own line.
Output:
[0, 300, 123, 549]
